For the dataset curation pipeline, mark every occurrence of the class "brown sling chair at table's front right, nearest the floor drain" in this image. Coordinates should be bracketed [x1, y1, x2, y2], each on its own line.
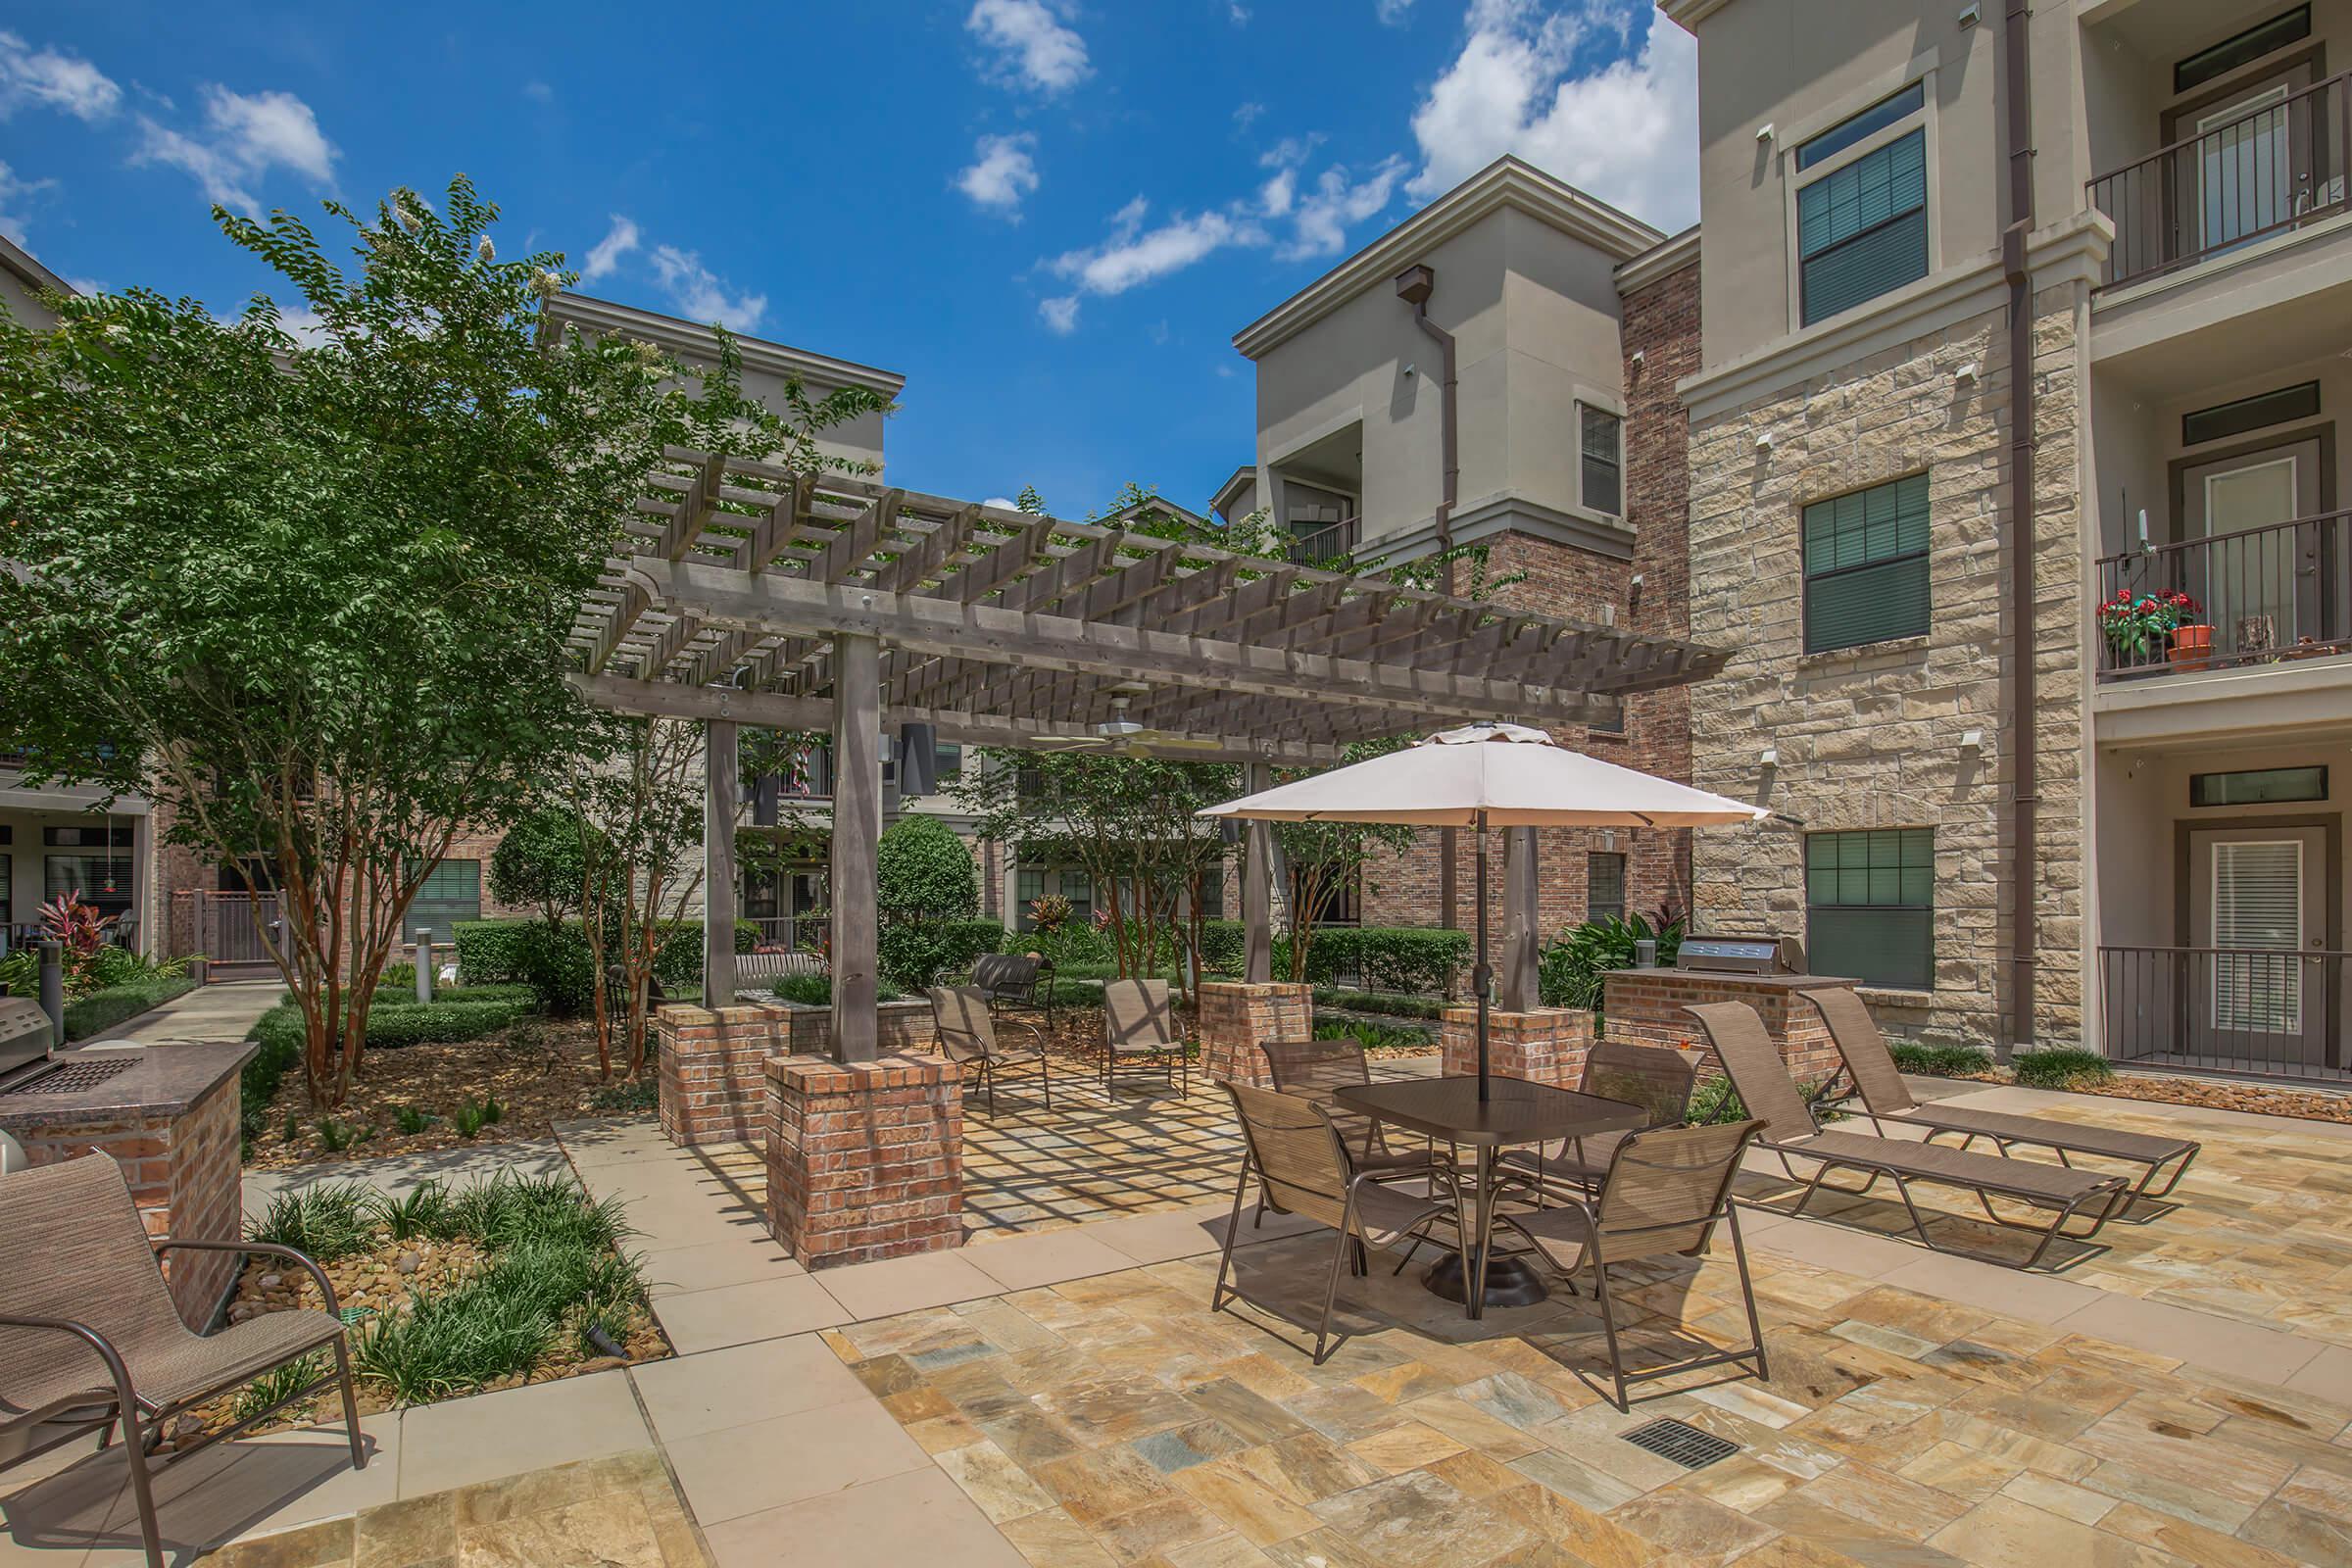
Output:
[1500, 1121, 1771, 1410]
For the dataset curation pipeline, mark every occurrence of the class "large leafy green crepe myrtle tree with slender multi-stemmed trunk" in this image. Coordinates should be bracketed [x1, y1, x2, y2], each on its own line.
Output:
[0, 176, 889, 1104]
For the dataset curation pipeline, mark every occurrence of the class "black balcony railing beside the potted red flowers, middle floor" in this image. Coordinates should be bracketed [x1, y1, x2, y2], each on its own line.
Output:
[2098, 513, 2352, 679]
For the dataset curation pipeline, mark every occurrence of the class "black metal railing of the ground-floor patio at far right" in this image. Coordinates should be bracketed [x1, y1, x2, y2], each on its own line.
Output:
[2098, 948, 2352, 1079]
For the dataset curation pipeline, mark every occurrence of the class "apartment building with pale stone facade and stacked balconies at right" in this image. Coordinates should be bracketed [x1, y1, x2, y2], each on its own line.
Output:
[1660, 0, 2352, 1077]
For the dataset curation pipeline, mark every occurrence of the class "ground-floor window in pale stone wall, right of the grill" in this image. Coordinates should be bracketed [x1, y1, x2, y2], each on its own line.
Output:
[1804, 827, 1936, 990]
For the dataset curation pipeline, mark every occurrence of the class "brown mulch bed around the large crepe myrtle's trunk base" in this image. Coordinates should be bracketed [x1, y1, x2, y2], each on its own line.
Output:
[245, 1018, 654, 1171]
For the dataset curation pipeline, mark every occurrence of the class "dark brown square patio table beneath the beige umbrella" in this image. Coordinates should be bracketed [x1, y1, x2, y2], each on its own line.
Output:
[1331, 1077, 1648, 1319]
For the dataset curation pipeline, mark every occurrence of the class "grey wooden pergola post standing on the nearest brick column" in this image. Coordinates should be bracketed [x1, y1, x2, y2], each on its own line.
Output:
[833, 635, 882, 1062]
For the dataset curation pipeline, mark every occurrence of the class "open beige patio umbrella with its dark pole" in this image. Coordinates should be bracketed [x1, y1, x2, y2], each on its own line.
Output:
[1201, 724, 1771, 1101]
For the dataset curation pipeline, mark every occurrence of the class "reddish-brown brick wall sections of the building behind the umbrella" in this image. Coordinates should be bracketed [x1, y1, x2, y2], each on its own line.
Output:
[1364, 264, 1700, 945]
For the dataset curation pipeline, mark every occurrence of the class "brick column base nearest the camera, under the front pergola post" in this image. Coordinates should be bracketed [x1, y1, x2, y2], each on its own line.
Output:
[766, 1055, 964, 1269]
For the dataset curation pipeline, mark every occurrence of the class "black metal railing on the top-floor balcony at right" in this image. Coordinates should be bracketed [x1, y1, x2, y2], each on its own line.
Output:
[2088, 75, 2352, 287]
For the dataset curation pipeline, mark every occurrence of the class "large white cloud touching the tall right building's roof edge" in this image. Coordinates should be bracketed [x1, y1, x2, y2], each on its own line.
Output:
[1406, 0, 1698, 228]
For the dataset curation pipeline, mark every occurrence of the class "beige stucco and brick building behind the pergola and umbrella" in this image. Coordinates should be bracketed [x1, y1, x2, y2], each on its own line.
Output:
[1211, 158, 1700, 945]
